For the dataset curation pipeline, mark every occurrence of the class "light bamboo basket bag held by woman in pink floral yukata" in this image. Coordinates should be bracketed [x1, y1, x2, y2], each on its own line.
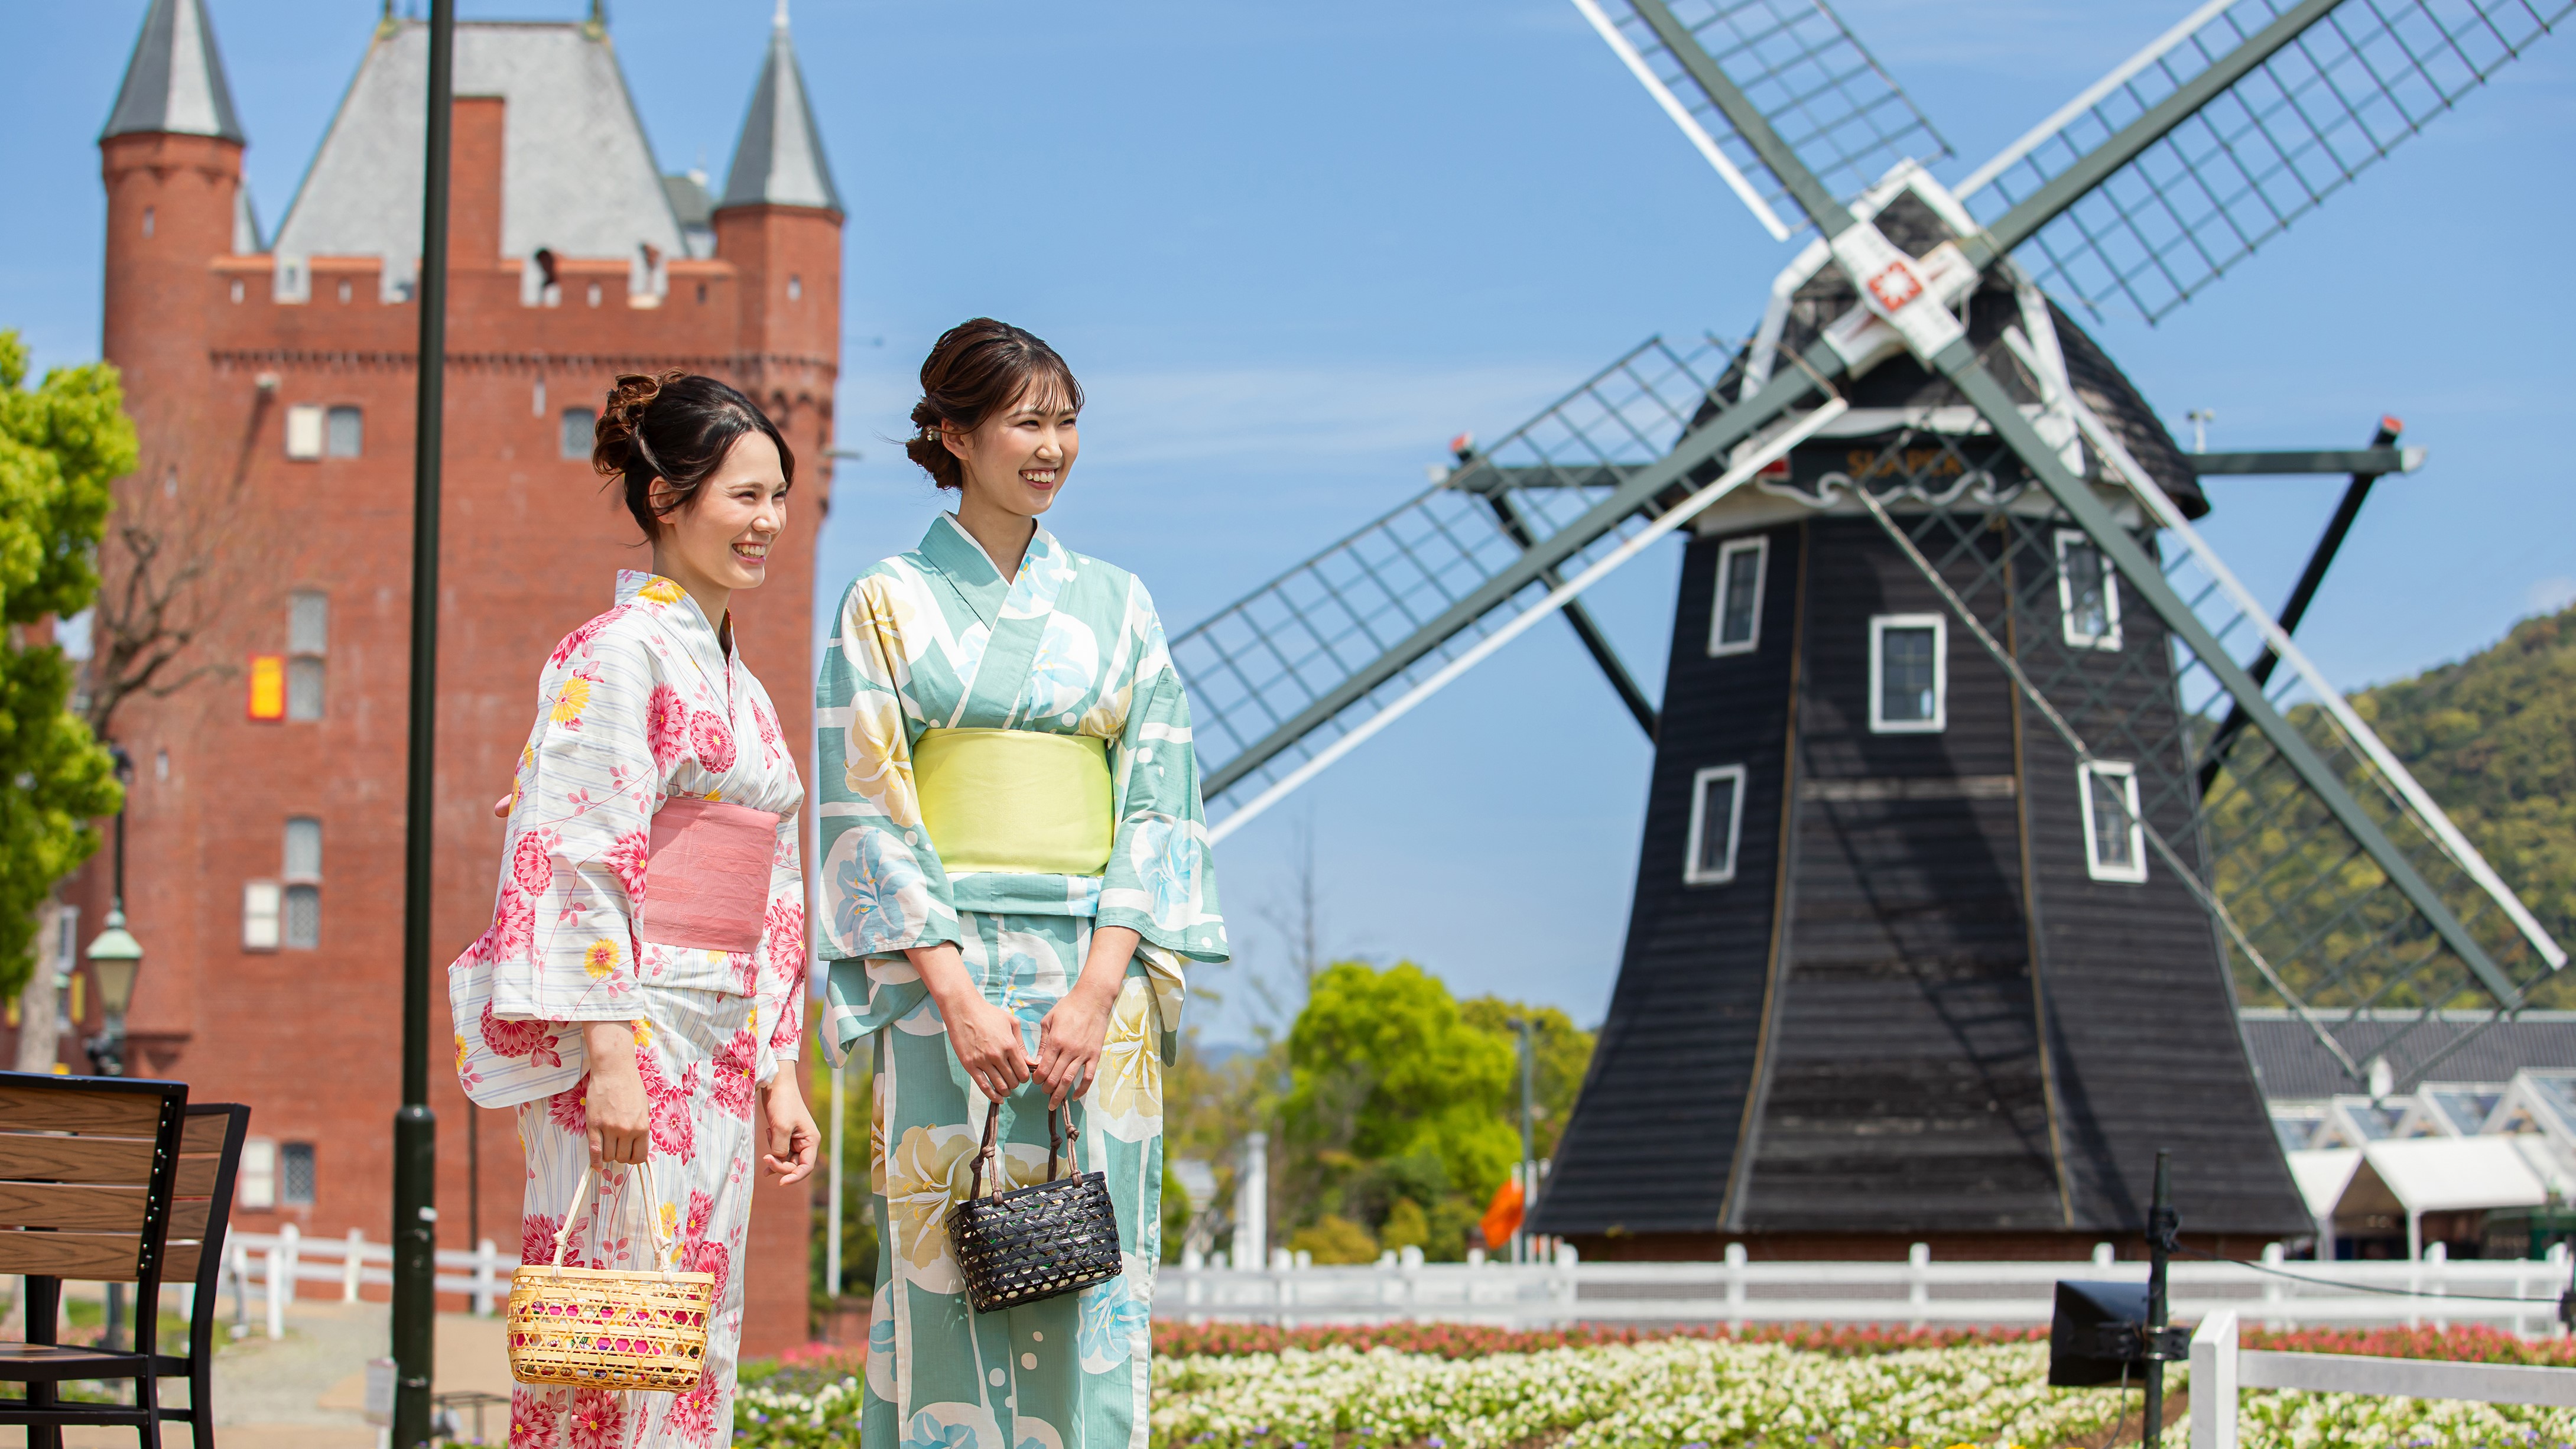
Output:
[510, 1161, 716, 1392]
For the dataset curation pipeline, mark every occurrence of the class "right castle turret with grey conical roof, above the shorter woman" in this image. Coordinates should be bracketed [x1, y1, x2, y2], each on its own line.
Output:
[716, 0, 842, 453]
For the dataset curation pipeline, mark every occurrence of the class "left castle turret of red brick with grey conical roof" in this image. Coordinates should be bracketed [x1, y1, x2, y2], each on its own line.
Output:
[98, 0, 242, 409]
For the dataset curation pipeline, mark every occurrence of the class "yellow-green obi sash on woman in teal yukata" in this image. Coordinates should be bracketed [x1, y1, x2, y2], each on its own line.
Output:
[912, 729, 1115, 875]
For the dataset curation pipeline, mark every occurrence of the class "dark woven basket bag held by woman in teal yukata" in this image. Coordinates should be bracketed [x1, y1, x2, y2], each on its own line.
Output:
[948, 1102, 1126, 1312]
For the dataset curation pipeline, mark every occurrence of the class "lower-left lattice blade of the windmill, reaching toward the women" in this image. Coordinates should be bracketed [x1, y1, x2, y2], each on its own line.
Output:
[1172, 340, 1731, 821]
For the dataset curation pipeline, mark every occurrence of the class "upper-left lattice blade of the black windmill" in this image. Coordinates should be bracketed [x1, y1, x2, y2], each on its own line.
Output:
[1600, 0, 1950, 229]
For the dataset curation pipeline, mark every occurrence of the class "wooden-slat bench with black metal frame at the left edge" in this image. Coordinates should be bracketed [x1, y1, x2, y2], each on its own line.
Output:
[0, 1073, 250, 1449]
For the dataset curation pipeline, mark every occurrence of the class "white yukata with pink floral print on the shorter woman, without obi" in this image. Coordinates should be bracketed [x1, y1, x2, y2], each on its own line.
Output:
[448, 571, 806, 1449]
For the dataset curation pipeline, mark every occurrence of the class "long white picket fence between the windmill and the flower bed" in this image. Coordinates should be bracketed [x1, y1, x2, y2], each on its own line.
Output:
[1154, 1243, 2568, 1333]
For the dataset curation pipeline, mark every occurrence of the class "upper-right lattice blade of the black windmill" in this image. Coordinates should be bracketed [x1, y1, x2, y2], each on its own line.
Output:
[1968, 0, 2576, 321]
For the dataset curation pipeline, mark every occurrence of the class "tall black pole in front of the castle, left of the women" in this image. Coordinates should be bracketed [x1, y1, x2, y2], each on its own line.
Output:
[394, 0, 456, 1449]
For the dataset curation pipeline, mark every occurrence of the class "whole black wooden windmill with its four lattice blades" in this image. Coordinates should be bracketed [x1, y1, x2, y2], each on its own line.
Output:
[1175, 0, 2576, 1259]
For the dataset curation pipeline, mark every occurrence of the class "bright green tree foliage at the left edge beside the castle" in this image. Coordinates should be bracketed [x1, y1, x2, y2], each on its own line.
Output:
[0, 332, 134, 996]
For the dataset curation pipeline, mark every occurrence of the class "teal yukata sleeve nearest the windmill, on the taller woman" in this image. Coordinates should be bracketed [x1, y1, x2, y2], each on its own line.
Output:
[1092, 579, 1232, 1060]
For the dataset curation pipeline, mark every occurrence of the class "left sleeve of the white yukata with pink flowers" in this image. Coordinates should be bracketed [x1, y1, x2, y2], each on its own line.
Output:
[484, 631, 675, 1022]
